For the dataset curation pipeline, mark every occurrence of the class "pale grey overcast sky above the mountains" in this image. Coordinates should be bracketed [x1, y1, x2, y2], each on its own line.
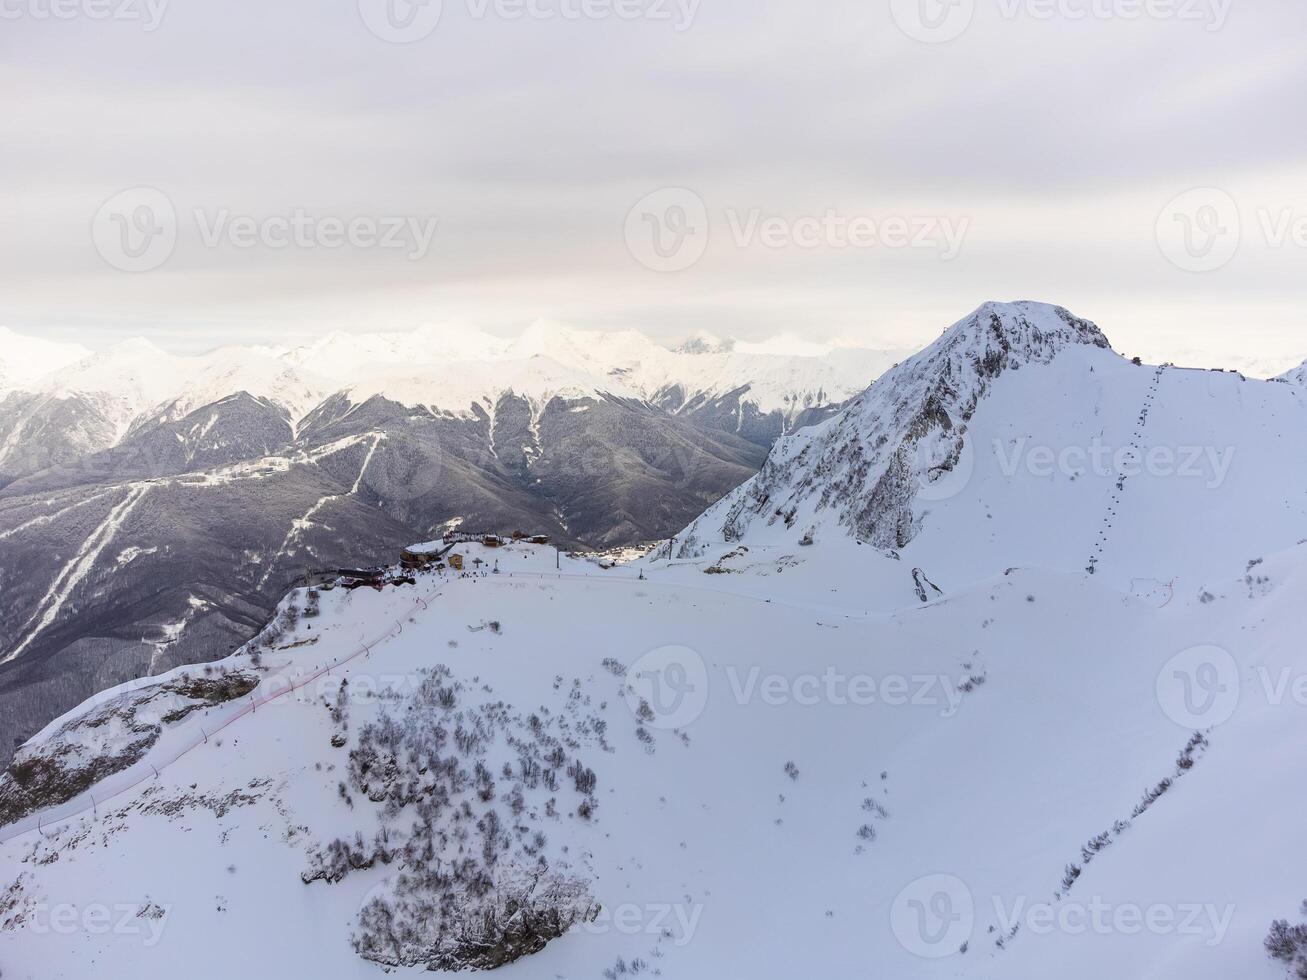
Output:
[0, 0, 1307, 367]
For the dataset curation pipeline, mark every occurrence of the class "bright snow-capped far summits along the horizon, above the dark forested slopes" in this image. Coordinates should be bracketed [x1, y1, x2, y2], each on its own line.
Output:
[0, 323, 903, 481]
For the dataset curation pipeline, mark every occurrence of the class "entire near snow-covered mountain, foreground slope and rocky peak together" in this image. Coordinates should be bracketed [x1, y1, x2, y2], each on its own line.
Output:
[0, 303, 1307, 980]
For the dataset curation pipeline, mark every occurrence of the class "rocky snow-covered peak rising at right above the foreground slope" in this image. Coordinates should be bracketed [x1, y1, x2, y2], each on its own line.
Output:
[674, 303, 1307, 605]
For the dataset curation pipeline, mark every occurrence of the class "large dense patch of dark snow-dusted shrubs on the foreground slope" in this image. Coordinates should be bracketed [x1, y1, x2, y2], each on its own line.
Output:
[302, 666, 599, 971]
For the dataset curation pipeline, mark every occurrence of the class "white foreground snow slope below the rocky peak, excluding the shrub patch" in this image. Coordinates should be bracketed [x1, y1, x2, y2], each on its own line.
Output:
[0, 545, 1307, 980]
